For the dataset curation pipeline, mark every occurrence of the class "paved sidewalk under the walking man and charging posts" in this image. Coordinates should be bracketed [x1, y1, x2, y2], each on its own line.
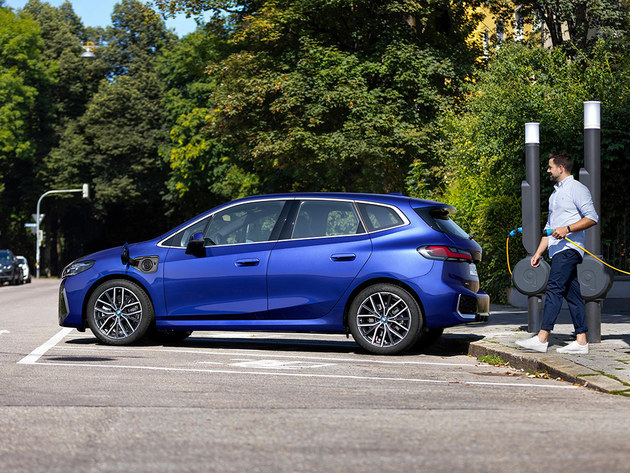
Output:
[443, 305, 630, 395]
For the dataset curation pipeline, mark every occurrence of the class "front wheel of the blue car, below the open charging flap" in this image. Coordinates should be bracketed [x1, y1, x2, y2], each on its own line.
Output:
[86, 279, 155, 345]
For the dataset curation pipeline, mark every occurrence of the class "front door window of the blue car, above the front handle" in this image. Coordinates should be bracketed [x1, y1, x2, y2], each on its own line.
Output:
[204, 200, 285, 245]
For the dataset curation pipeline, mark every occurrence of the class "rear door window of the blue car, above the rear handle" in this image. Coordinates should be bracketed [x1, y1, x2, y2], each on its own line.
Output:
[291, 200, 364, 239]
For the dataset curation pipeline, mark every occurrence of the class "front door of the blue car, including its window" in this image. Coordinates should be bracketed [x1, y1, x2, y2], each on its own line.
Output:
[164, 200, 285, 320]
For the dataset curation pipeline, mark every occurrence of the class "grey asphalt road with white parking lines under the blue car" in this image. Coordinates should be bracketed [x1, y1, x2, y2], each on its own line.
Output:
[0, 280, 630, 473]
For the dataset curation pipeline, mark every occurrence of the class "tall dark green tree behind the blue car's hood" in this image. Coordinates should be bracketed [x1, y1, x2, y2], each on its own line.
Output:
[46, 0, 175, 262]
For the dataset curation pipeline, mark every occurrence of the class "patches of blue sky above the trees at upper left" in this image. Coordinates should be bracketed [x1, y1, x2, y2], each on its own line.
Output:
[4, 0, 202, 36]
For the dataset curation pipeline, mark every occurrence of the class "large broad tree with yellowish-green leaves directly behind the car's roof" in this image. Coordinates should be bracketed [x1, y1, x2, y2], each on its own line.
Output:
[158, 0, 488, 192]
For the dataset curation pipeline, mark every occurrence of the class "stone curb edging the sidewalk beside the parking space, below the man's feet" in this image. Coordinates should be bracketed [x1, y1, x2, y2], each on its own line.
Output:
[468, 341, 630, 393]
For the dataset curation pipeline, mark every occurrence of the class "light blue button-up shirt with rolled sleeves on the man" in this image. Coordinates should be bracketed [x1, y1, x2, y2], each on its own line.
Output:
[545, 176, 599, 258]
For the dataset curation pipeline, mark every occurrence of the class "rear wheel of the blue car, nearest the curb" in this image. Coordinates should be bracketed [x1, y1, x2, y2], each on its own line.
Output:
[348, 284, 423, 355]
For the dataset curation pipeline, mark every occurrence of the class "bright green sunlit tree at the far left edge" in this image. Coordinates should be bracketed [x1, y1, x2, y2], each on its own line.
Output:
[0, 4, 54, 252]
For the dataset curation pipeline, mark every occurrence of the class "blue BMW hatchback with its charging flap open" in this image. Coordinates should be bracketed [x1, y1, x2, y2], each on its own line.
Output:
[59, 193, 490, 355]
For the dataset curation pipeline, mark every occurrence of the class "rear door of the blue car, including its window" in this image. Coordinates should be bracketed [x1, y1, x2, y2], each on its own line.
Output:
[267, 199, 372, 319]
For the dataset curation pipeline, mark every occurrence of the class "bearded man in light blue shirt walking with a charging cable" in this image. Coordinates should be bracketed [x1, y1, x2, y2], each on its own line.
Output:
[516, 149, 599, 354]
